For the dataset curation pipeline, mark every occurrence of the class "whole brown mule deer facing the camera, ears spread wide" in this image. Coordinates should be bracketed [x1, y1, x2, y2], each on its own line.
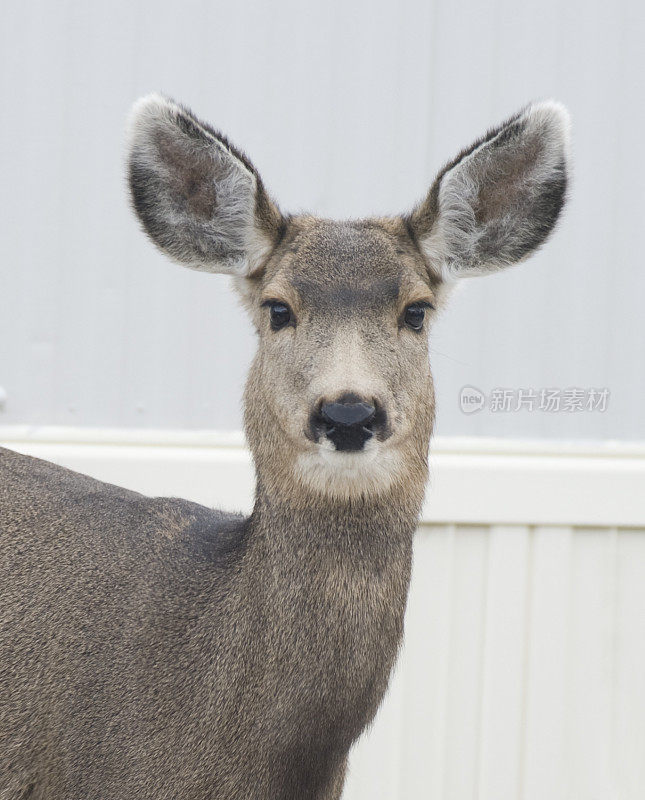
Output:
[0, 95, 568, 800]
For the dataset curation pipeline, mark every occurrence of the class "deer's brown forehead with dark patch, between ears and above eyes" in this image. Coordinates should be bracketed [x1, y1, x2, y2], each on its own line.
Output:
[262, 223, 418, 311]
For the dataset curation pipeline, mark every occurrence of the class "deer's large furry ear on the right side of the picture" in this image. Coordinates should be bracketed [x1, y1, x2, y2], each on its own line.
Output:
[408, 101, 569, 280]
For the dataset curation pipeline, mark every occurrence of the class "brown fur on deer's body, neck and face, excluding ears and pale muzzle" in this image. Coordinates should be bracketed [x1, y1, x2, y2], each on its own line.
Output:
[0, 219, 433, 800]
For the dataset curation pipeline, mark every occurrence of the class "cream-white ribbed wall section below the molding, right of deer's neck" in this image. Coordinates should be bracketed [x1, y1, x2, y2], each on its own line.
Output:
[343, 526, 645, 800]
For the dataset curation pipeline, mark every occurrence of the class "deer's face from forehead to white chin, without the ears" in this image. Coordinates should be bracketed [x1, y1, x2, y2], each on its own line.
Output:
[243, 218, 438, 494]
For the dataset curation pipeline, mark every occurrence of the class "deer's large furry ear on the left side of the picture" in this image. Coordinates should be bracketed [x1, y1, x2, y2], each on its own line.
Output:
[128, 94, 284, 276]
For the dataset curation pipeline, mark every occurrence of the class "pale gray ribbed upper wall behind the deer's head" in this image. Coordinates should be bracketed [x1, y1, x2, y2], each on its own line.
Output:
[0, 0, 645, 439]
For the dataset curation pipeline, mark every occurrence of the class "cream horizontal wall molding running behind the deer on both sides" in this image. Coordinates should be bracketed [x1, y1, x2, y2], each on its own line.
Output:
[0, 426, 645, 527]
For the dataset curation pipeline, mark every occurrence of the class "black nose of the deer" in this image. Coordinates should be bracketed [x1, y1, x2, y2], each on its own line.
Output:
[311, 394, 382, 450]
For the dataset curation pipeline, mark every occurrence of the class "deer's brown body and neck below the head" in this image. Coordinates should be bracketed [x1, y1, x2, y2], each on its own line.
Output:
[0, 450, 417, 800]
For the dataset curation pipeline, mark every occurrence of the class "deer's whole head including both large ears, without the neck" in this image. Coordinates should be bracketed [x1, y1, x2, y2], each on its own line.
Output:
[129, 96, 568, 497]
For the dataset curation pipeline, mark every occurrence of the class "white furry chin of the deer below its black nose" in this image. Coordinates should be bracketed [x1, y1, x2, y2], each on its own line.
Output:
[295, 439, 401, 499]
